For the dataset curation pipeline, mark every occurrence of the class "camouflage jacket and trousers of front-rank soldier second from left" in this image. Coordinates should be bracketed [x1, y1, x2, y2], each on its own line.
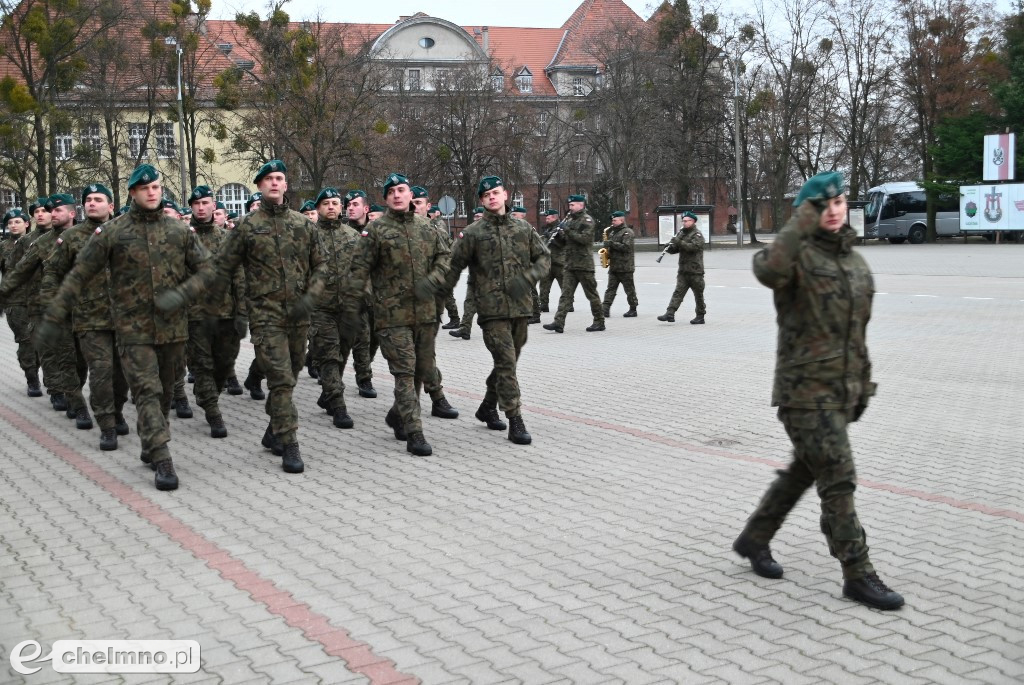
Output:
[182, 198, 327, 445]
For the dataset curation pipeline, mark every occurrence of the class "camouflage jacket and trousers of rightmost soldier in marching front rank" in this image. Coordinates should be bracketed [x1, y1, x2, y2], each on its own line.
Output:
[449, 211, 551, 418]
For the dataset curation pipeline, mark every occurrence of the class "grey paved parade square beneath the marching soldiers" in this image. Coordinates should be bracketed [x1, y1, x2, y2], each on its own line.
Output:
[0, 242, 1024, 685]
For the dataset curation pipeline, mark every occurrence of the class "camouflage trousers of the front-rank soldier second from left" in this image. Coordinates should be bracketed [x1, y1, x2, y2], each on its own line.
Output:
[252, 326, 309, 444]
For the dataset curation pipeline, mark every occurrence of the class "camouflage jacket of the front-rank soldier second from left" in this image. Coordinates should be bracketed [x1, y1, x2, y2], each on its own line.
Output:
[182, 204, 327, 331]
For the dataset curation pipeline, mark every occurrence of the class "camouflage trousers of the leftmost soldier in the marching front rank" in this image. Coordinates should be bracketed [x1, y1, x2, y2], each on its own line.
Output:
[118, 342, 185, 462]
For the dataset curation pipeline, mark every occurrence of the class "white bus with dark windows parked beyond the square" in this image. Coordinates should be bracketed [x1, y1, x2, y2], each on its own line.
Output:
[864, 181, 961, 244]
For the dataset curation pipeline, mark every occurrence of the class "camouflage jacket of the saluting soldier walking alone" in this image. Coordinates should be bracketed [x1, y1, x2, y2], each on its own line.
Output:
[754, 217, 876, 410]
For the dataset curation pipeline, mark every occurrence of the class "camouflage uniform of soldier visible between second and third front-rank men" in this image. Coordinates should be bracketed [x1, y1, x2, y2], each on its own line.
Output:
[309, 217, 359, 412]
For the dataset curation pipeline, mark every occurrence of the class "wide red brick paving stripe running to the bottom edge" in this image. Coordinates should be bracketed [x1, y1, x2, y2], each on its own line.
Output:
[0, 406, 420, 685]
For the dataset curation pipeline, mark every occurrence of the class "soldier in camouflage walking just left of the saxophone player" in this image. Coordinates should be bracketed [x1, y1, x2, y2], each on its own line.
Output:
[544, 195, 604, 333]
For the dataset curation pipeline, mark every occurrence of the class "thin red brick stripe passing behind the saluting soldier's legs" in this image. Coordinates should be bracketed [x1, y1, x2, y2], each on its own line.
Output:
[445, 387, 1024, 523]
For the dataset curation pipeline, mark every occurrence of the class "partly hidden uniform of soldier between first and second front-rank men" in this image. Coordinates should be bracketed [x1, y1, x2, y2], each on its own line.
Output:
[186, 218, 246, 423]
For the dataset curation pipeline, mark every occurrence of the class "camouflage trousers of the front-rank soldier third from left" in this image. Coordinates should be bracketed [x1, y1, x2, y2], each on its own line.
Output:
[377, 324, 437, 433]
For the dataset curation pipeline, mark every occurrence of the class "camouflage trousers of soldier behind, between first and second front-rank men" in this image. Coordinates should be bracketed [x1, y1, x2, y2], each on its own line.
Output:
[185, 318, 240, 421]
